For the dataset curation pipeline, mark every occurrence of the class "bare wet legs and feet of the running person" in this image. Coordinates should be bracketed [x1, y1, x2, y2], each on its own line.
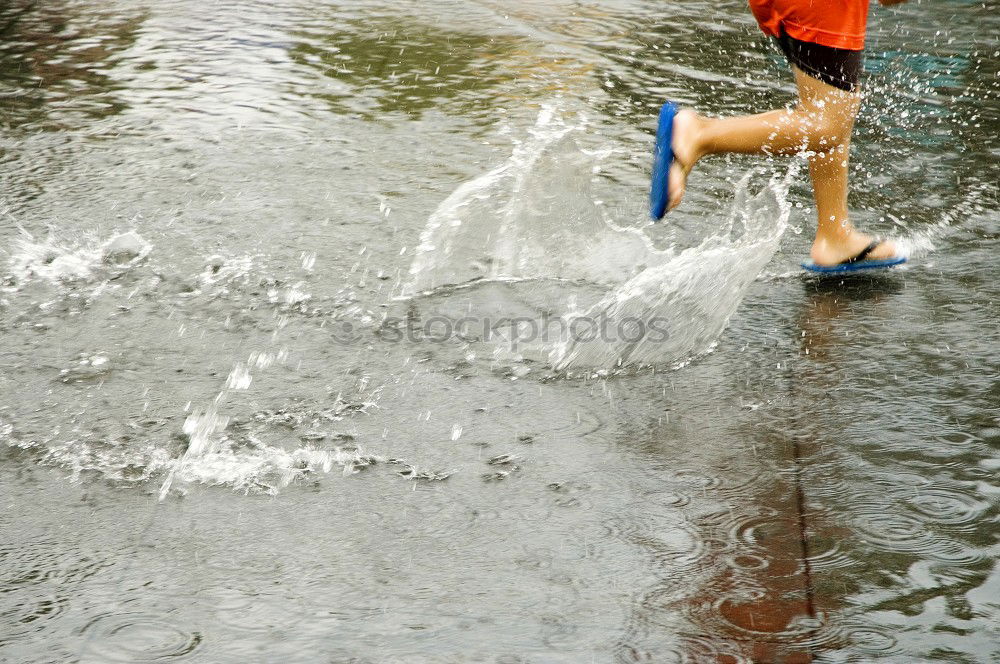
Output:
[670, 67, 896, 265]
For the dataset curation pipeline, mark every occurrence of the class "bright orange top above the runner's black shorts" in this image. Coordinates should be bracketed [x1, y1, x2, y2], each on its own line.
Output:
[750, 0, 868, 51]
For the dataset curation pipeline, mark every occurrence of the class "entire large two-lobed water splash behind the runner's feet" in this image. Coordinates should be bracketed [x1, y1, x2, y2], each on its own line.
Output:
[402, 108, 800, 370]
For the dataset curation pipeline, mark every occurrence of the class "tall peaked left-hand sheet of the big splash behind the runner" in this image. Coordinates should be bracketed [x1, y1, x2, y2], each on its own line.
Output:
[402, 106, 653, 297]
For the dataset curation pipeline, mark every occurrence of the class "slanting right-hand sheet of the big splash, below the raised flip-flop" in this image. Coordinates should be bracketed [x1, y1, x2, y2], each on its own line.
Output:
[550, 169, 798, 369]
